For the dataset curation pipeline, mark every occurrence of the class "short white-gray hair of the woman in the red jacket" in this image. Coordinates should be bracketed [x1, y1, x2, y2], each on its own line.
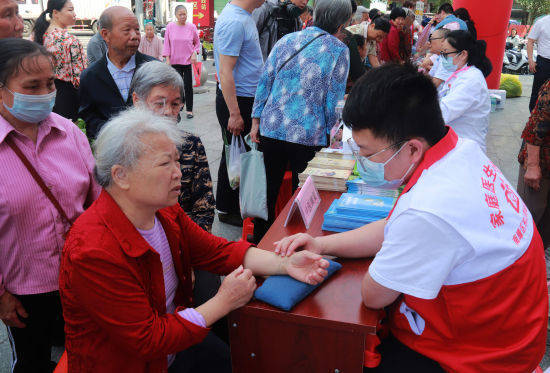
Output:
[94, 107, 183, 188]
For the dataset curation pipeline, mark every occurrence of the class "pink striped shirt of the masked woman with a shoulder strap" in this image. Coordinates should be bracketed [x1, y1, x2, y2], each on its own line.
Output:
[0, 113, 100, 295]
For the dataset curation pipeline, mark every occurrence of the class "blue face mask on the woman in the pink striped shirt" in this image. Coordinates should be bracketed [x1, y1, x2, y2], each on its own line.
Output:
[4, 88, 57, 123]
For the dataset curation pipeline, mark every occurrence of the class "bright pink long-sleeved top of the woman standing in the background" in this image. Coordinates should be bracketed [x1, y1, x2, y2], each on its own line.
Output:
[162, 22, 201, 65]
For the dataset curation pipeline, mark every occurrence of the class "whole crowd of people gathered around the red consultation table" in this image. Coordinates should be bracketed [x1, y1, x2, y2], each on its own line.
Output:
[0, 0, 550, 373]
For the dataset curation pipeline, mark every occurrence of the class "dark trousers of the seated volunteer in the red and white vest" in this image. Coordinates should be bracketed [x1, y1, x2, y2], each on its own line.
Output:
[363, 335, 445, 373]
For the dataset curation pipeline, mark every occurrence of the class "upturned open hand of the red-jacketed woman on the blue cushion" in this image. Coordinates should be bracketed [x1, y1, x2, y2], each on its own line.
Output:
[286, 250, 329, 285]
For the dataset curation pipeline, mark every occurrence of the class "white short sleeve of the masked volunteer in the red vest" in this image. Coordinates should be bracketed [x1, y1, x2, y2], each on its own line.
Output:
[369, 210, 471, 299]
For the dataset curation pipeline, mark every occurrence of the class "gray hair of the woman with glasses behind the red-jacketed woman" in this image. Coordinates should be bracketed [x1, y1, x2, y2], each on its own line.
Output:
[130, 61, 183, 100]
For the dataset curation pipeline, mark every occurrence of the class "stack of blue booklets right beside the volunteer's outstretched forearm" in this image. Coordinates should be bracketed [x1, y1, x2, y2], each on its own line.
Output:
[323, 193, 395, 232]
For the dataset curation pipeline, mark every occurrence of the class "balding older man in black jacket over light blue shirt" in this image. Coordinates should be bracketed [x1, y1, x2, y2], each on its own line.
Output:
[78, 6, 154, 140]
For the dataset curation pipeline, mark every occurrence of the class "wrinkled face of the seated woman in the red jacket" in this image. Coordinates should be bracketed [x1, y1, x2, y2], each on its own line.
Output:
[122, 133, 181, 211]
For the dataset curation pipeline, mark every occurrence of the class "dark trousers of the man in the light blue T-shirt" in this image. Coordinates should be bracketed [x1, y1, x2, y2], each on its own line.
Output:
[216, 88, 254, 215]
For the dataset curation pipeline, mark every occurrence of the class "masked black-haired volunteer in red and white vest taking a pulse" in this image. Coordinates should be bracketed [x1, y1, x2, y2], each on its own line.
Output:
[275, 65, 548, 373]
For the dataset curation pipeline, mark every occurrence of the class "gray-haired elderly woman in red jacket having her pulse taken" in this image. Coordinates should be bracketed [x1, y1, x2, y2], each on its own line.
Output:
[60, 109, 328, 373]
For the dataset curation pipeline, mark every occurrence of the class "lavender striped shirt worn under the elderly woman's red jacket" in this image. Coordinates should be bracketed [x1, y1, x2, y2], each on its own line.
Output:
[138, 216, 206, 365]
